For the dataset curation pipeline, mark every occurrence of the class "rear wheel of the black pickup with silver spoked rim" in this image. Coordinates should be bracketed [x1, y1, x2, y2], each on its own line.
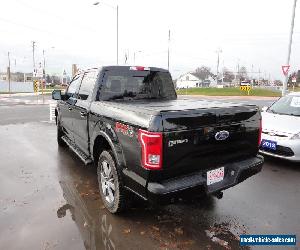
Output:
[97, 151, 128, 214]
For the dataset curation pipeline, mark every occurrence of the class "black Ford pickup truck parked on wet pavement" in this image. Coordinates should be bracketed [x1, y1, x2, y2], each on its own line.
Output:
[52, 66, 263, 213]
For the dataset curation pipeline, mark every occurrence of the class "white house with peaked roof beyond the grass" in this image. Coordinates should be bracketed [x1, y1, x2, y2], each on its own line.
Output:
[176, 72, 216, 89]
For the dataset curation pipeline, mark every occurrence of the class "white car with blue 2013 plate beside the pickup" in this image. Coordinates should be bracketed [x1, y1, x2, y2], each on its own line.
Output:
[260, 92, 300, 162]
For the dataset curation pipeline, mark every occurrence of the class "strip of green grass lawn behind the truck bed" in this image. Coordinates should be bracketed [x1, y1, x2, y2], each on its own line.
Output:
[177, 88, 281, 97]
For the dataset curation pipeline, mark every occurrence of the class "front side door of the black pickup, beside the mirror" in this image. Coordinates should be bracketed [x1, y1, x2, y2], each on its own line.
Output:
[60, 75, 82, 140]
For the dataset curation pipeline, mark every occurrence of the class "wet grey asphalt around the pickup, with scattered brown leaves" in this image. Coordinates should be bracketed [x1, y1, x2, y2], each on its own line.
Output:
[0, 94, 300, 249]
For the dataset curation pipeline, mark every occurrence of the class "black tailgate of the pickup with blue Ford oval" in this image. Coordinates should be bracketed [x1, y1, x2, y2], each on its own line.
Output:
[150, 105, 261, 181]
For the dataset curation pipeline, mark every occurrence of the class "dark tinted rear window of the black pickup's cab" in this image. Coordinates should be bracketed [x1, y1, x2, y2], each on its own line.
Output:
[100, 69, 177, 101]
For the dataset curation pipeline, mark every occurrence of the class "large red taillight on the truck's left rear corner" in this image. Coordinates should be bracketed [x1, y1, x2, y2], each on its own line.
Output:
[139, 129, 162, 170]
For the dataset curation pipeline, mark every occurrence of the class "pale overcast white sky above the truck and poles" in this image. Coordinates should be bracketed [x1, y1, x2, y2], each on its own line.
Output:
[0, 0, 300, 79]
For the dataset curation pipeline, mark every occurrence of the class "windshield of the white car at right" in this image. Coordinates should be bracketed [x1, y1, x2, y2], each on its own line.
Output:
[268, 95, 300, 116]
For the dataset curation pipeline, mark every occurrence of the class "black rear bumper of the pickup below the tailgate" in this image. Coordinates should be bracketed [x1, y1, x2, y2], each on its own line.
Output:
[147, 155, 264, 201]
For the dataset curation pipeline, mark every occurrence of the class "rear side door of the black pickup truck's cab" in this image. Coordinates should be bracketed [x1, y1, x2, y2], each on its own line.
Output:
[73, 70, 98, 155]
